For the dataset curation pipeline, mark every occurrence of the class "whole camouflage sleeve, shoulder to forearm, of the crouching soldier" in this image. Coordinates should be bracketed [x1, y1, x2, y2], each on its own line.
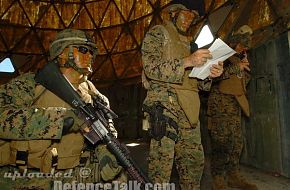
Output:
[0, 73, 66, 140]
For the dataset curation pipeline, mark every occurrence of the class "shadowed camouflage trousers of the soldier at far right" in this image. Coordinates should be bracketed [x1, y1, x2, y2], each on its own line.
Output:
[209, 106, 243, 175]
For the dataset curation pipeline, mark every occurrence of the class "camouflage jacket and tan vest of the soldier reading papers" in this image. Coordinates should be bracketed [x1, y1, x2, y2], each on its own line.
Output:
[142, 22, 211, 121]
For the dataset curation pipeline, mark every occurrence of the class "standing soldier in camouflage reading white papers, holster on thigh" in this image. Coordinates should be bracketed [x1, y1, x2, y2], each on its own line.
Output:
[142, 1, 223, 190]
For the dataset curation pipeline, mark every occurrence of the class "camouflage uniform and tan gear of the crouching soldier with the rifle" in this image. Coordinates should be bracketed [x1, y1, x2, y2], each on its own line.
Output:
[0, 73, 125, 190]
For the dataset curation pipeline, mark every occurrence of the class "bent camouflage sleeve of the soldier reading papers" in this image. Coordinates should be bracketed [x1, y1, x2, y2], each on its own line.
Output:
[141, 25, 184, 83]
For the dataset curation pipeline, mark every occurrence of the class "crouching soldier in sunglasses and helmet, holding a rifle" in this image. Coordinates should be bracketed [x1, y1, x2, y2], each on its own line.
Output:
[0, 29, 126, 190]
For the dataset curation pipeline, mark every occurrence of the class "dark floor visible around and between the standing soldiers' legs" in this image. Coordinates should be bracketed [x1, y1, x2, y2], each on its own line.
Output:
[120, 140, 290, 190]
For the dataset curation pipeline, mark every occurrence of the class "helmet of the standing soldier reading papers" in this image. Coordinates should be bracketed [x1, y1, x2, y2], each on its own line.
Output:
[165, 0, 205, 16]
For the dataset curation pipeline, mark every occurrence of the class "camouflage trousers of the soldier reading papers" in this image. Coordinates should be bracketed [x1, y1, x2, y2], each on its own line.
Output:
[148, 109, 204, 190]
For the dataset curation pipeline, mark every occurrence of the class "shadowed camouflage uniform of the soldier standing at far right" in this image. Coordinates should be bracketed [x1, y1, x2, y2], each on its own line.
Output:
[208, 56, 250, 175]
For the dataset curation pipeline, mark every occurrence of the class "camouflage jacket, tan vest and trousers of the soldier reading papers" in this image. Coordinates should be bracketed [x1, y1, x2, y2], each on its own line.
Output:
[142, 22, 212, 190]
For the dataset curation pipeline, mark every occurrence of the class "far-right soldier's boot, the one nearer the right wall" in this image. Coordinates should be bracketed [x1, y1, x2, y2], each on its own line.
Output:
[228, 171, 258, 190]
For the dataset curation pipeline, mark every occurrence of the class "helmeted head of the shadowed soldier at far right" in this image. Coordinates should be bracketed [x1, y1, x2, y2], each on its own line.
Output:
[229, 25, 253, 48]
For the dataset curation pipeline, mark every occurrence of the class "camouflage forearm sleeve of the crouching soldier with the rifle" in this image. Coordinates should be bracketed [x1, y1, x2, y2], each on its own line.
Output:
[0, 107, 66, 140]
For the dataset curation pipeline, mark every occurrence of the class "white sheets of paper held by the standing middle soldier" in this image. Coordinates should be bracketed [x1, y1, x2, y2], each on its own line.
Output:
[189, 38, 236, 80]
